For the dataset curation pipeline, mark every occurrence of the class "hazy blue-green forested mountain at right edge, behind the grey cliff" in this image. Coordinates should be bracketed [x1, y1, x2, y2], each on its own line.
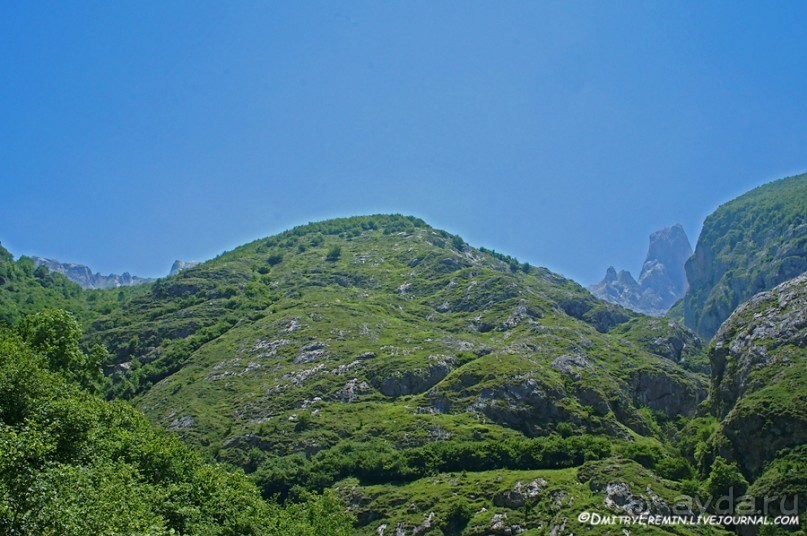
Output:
[672, 174, 807, 339]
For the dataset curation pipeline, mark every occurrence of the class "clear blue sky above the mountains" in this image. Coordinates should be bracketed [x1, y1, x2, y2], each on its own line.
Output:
[0, 0, 807, 284]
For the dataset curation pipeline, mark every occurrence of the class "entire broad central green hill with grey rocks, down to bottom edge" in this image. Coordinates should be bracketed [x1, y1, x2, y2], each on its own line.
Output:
[80, 216, 724, 534]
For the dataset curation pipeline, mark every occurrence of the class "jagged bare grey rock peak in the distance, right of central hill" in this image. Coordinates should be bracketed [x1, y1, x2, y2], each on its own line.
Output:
[588, 224, 692, 316]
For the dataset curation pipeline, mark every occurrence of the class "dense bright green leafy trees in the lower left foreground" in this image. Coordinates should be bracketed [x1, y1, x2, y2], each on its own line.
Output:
[0, 310, 351, 535]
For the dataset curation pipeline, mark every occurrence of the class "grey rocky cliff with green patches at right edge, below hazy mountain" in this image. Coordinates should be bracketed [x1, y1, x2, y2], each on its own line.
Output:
[710, 274, 807, 477]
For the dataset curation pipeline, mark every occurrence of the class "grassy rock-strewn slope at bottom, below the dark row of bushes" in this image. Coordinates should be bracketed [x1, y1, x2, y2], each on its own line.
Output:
[336, 458, 740, 536]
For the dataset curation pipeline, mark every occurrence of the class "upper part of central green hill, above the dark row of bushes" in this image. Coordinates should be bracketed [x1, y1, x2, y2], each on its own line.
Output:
[89, 216, 705, 444]
